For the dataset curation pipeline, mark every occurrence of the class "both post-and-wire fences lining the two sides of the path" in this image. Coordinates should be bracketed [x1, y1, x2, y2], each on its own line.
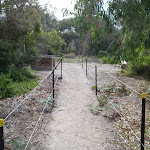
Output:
[0, 57, 150, 150]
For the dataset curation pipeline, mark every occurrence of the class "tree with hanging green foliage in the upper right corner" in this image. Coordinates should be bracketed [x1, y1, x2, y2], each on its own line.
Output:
[109, 0, 150, 63]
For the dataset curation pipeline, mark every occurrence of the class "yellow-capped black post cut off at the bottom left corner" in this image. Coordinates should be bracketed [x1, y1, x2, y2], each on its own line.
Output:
[0, 119, 4, 150]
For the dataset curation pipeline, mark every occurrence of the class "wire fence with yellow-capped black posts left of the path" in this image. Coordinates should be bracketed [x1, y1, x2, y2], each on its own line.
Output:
[0, 58, 62, 150]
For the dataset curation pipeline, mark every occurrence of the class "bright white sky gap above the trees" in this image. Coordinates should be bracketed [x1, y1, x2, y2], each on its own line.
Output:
[39, 0, 75, 20]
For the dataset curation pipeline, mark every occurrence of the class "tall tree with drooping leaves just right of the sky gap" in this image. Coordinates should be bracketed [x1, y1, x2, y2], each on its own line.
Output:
[74, 0, 105, 55]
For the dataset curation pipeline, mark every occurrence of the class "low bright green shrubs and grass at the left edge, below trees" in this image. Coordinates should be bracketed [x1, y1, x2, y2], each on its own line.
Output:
[0, 67, 39, 99]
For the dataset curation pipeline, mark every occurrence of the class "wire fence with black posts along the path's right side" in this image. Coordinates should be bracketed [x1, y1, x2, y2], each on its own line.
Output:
[81, 57, 150, 150]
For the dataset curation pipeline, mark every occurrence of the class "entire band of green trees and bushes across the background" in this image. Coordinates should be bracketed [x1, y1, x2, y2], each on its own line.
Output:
[0, 0, 150, 97]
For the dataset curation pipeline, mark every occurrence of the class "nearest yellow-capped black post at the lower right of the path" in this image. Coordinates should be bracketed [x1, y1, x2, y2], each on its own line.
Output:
[141, 93, 146, 150]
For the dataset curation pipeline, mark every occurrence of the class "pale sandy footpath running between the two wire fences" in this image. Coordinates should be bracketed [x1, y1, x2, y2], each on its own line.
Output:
[41, 63, 120, 150]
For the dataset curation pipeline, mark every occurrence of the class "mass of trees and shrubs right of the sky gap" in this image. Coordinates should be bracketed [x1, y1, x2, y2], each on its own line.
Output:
[74, 0, 150, 78]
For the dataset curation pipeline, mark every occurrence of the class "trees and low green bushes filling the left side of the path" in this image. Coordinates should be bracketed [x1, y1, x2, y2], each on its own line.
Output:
[0, 0, 64, 98]
